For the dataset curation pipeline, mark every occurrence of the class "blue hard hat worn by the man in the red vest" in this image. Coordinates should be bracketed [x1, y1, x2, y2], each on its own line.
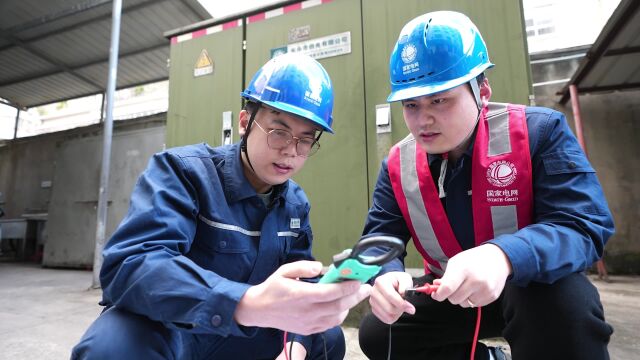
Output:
[387, 11, 493, 102]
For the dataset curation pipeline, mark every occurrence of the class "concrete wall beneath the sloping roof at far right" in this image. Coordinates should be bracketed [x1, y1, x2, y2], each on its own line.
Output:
[531, 49, 640, 274]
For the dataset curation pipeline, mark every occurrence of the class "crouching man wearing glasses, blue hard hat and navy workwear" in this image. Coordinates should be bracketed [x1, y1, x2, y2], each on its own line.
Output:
[72, 54, 370, 359]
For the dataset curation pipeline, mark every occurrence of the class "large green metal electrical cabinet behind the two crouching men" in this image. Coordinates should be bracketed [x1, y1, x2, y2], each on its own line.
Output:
[167, 0, 531, 267]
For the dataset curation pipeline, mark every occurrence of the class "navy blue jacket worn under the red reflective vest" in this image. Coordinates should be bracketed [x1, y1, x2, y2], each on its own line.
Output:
[364, 107, 614, 285]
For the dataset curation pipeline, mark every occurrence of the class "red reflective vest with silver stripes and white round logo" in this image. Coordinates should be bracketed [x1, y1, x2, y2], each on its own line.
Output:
[388, 103, 533, 276]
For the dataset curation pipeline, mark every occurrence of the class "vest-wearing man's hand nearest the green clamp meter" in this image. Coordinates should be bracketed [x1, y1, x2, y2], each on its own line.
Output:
[369, 271, 416, 324]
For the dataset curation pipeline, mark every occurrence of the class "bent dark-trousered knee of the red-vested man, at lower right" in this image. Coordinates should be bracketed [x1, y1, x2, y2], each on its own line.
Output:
[503, 273, 613, 359]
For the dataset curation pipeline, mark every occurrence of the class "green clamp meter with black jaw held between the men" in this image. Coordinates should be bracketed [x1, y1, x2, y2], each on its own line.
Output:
[319, 235, 404, 284]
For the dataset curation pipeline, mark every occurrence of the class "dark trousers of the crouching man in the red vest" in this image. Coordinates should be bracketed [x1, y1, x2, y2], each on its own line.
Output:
[359, 273, 613, 360]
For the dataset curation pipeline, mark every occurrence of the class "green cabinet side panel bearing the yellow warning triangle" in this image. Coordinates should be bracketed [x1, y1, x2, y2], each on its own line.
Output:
[166, 25, 243, 147]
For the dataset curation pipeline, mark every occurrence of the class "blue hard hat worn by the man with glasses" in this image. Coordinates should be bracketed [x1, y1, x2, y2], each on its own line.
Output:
[241, 53, 333, 133]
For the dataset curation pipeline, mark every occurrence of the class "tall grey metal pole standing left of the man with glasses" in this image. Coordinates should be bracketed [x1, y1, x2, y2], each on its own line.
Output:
[92, 0, 122, 288]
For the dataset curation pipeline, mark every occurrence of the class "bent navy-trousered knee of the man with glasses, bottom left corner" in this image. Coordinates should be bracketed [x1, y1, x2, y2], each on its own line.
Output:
[71, 308, 174, 359]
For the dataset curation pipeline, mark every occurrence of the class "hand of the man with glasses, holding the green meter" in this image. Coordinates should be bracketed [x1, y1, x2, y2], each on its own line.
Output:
[235, 261, 371, 335]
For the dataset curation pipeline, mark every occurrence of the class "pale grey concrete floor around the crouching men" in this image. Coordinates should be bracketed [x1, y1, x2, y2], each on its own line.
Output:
[0, 262, 640, 360]
